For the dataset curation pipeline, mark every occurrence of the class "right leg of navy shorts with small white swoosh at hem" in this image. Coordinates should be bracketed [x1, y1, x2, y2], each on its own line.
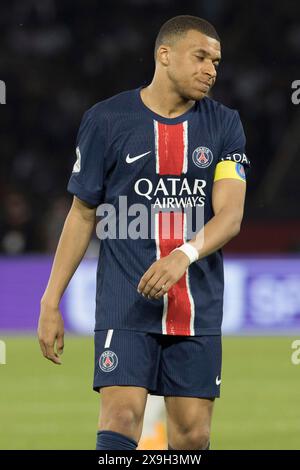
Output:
[158, 336, 222, 396]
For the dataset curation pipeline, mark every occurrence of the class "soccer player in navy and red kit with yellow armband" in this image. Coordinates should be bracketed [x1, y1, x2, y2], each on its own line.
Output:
[38, 15, 249, 450]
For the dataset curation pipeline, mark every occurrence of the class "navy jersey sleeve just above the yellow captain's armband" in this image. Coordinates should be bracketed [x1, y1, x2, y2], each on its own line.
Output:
[216, 111, 250, 179]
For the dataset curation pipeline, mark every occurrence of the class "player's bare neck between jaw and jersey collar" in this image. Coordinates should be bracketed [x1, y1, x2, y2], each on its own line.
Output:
[141, 76, 195, 118]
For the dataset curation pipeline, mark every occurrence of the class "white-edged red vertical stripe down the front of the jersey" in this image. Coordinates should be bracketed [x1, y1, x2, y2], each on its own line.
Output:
[156, 123, 191, 335]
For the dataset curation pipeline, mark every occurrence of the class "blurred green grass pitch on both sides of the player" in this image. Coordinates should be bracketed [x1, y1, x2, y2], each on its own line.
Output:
[0, 336, 300, 449]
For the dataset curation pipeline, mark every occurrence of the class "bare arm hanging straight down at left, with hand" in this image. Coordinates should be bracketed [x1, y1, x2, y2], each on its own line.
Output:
[38, 197, 96, 364]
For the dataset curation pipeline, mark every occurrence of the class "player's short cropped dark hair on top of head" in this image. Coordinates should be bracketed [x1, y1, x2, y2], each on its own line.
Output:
[154, 15, 220, 60]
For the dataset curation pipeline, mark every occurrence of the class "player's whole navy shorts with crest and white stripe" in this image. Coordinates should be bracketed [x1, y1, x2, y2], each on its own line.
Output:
[93, 330, 222, 398]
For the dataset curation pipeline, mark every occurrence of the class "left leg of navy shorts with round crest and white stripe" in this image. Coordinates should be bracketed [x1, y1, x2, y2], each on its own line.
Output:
[93, 330, 161, 391]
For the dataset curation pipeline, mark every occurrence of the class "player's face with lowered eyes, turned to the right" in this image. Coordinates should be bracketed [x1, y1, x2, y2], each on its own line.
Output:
[167, 30, 221, 100]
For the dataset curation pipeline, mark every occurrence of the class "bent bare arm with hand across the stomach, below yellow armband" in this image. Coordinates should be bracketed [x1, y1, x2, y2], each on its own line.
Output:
[138, 178, 246, 299]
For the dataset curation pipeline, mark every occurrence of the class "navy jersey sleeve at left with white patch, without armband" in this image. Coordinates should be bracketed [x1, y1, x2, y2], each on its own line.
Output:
[67, 111, 106, 206]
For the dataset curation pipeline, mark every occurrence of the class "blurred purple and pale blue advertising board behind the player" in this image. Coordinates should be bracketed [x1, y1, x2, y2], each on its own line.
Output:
[0, 256, 300, 335]
